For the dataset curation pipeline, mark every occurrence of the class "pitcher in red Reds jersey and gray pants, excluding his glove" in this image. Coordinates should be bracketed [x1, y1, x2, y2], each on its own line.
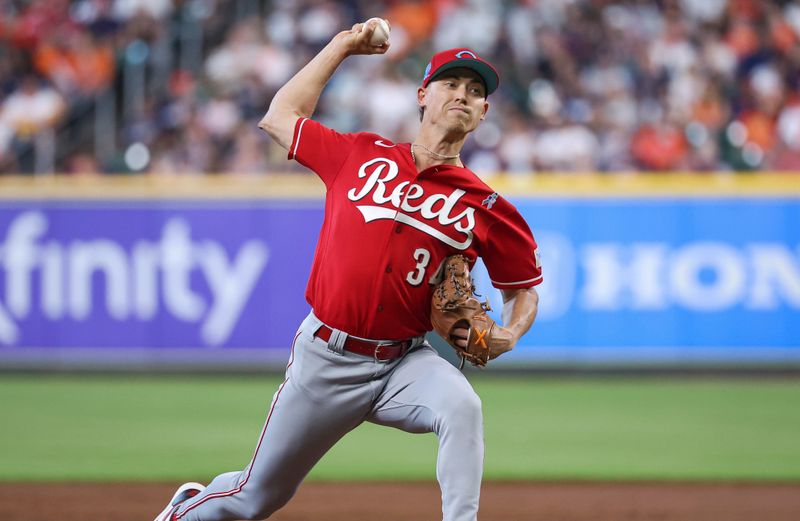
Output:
[156, 18, 542, 521]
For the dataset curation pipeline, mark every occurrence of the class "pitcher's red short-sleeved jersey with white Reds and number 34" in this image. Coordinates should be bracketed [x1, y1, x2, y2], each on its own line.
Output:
[289, 118, 542, 340]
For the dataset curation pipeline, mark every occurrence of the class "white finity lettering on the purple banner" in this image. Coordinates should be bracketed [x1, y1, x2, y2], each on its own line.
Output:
[0, 211, 269, 346]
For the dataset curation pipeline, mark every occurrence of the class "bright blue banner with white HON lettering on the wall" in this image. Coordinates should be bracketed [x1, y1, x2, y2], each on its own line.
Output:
[479, 198, 800, 362]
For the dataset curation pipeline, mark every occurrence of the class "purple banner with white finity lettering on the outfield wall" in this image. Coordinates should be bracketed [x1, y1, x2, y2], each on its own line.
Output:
[0, 201, 322, 350]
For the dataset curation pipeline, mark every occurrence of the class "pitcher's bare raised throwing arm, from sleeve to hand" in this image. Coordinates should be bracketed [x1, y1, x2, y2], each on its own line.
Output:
[258, 21, 389, 150]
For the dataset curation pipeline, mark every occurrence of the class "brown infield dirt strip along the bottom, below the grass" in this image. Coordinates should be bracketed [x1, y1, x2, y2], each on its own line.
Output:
[0, 482, 800, 521]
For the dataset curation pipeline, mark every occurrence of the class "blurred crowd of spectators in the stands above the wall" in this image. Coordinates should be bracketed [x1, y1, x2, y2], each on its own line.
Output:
[0, 0, 800, 176]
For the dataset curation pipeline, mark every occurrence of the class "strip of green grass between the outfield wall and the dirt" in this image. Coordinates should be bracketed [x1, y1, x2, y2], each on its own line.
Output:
[0, 375, 800, 480]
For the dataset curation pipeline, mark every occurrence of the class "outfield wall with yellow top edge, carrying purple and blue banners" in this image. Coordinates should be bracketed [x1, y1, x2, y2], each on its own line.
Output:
[0, 174, 800, 369]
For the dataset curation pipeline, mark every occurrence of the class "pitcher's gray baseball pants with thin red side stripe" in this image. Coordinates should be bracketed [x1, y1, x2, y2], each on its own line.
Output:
[176, 313, 483, 521]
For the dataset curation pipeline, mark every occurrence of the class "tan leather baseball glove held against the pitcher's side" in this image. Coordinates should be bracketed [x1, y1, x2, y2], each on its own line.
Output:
[431, 255, 508, 367]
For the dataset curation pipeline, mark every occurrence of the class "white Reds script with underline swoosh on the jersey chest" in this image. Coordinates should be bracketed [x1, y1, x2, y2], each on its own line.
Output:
[347, 157, 475, 250]
